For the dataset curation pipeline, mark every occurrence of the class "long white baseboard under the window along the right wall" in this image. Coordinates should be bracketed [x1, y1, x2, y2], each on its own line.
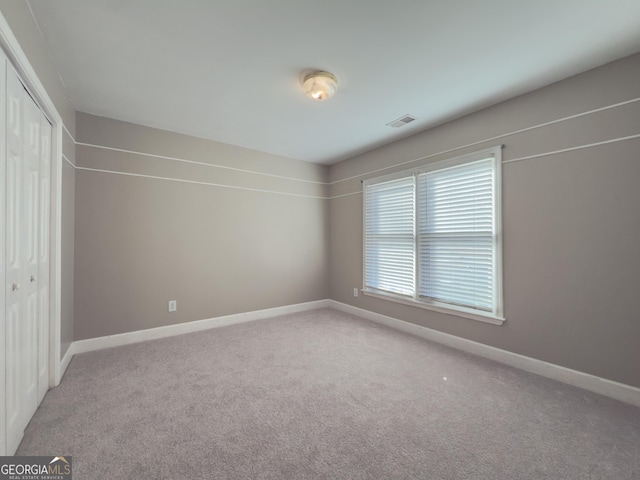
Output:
[328, 300, 640, 407]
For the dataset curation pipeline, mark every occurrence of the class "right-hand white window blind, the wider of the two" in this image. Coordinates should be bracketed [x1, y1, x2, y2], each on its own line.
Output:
[418, 159, 495, 312]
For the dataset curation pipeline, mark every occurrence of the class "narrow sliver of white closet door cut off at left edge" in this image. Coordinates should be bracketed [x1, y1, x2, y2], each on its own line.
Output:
[0, 47, 7, 455]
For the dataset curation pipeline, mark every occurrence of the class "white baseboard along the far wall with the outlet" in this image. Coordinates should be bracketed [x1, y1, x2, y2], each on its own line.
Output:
[72, 300, 329, 361]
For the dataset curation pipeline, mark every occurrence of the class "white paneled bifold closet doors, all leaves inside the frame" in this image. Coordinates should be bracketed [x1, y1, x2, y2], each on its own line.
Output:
[0, 61, 51, 455]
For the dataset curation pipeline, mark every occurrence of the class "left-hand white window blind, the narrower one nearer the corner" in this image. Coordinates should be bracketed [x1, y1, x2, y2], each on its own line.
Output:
[364, 176, 415, 296]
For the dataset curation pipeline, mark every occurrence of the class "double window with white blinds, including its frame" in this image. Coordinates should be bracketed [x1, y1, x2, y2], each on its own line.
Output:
[363, 147, 503, 323]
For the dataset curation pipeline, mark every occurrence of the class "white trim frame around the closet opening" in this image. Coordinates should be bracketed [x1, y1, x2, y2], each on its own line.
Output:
[0, 12, 65, 394]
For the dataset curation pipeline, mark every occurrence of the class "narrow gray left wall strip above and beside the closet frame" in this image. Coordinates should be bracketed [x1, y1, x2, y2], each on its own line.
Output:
[0, 0, 75, 356]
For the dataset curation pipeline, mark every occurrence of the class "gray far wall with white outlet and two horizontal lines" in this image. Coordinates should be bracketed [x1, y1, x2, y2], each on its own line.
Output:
[74, 113, 328, 340]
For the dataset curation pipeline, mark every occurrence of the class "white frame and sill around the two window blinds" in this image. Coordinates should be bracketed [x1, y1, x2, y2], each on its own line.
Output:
[361, 145, 505, 325]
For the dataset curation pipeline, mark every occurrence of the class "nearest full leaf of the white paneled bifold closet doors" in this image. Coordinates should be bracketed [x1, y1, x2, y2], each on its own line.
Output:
[5, 64, 27, 454]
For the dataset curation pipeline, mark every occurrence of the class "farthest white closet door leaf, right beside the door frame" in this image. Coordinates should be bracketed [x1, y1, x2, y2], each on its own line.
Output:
[38, 113, 51, 405]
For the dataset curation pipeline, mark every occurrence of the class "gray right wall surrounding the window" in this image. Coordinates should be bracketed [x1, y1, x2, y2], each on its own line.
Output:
[329, 55, 640, 387]
